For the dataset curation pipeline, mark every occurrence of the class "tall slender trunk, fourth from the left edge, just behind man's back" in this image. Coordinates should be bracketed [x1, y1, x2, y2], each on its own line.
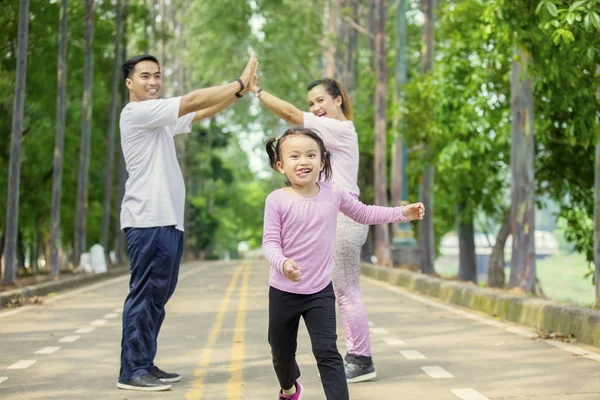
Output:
[102, 0, 123, 265]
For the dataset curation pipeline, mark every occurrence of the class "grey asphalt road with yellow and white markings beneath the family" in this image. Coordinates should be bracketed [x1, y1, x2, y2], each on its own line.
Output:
[0, 260, 600, 400]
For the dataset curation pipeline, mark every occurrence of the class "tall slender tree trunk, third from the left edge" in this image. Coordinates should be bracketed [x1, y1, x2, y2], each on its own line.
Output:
[73, 0, 94, 265]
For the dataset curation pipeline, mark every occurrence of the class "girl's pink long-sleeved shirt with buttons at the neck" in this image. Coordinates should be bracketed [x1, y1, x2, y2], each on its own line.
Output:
[262, 182, 407, 294]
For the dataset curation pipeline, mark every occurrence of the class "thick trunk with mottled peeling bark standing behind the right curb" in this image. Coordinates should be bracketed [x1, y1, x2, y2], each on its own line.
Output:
[509, 48, 536, 293]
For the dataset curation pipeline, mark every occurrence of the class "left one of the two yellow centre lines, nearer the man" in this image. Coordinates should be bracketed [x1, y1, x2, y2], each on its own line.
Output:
[185, 264, 244, 400]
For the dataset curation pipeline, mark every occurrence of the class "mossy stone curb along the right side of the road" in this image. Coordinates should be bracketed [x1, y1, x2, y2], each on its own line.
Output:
[361, 264, 600, 347]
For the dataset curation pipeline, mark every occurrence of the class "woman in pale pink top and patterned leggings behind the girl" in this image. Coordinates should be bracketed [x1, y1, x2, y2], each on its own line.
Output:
[249, 73, 376, 383]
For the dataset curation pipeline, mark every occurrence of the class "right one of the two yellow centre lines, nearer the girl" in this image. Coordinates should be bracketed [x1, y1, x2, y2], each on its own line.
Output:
[227, 263, 250, 400]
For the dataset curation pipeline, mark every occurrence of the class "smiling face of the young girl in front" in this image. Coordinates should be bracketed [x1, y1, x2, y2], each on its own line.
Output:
[277, 135, 325, 188]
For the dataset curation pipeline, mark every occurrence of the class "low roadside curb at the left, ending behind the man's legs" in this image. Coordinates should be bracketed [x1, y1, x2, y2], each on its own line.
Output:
[0, 266, 129, 309]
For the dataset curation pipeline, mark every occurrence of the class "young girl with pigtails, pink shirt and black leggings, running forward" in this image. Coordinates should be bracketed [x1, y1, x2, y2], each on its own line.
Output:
[263, 127, 424, 400]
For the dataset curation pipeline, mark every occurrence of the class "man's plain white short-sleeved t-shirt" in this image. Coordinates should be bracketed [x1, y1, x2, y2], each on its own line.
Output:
[120, 97, 195, 231]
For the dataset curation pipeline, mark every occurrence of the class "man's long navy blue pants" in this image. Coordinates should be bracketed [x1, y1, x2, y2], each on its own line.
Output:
[119, 226, 183, 381]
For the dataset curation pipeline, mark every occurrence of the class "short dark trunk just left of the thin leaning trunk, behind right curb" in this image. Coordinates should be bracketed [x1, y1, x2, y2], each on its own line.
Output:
[456, 201, 477, 283]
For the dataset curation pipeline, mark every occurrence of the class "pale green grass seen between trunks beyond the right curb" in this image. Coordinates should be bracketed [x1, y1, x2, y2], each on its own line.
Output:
[435, 253, 595, 307]
